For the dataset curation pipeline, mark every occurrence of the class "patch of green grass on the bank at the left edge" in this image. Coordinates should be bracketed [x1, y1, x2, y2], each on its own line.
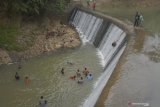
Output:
[0, 25, 23, 51]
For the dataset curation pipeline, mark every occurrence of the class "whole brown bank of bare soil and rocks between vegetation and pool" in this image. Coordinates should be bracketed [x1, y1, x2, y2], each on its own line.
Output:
[0, 17, 80, 64]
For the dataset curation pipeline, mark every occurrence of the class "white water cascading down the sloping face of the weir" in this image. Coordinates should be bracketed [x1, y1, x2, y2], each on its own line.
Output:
[69, 9, 126, 107]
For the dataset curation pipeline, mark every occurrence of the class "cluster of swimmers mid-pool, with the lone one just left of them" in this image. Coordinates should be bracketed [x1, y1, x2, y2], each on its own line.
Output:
[61, 68, 93, 84]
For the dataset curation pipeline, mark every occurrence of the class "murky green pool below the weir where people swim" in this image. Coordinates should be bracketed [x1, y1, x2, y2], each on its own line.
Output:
[0, 45, 102, 107]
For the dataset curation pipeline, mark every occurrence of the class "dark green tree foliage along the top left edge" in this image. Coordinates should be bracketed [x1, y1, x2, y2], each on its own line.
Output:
[0, 0, 70, 16]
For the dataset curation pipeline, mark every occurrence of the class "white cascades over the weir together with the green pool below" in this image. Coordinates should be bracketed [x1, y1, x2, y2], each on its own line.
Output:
[0, 9, 127, 107]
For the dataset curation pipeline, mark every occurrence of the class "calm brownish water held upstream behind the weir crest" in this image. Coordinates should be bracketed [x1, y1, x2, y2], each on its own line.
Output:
[96, 4, 160, 107]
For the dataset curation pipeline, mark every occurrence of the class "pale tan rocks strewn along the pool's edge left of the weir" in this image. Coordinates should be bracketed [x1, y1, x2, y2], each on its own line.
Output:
[0, 20, 80, 64]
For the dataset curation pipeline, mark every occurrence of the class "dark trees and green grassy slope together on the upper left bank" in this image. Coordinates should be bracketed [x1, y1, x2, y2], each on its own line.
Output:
[0, 0, 70, 51]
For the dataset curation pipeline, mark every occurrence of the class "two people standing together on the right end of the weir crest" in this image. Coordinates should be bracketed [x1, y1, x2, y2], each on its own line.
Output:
[134, 12, 144, 27]
